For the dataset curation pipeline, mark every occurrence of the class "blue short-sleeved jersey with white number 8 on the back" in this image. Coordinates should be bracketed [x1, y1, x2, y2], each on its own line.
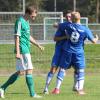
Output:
[60, 23, 94, 53]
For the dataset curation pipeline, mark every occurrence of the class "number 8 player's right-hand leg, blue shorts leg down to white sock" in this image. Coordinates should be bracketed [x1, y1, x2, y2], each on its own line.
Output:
[74, 53, 85, 95]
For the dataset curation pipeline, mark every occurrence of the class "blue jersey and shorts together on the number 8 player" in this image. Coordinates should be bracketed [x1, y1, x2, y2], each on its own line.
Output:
[59, 22, 94, 69]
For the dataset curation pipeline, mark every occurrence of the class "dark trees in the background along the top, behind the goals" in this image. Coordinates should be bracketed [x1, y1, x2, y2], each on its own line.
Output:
[0, 0, 100, 23]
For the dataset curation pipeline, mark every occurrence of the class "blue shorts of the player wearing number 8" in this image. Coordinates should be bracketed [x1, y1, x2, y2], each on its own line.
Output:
[60, 51, 85, 69]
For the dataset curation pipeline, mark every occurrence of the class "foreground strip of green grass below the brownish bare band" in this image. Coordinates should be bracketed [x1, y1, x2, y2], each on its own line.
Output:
[0, 71, 100, 100]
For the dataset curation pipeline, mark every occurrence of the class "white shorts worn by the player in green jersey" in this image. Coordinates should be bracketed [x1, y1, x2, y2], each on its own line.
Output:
[16, 54, 33, 71]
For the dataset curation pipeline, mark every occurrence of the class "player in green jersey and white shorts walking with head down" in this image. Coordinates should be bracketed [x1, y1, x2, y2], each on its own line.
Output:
[0, 5, 44, 98]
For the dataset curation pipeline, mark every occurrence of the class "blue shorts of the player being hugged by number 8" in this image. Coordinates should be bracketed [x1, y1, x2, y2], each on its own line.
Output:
[51, 46, 62, 67]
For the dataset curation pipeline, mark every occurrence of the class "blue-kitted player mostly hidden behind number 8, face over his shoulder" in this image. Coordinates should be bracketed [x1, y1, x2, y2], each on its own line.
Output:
[44, 13, 71, 94]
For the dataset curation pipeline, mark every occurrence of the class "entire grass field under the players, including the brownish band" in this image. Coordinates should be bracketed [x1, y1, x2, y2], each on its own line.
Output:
[0, 44, 100, 100]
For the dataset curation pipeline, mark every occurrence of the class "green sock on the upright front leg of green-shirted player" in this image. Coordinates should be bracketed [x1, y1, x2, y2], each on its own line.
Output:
[26, 74, 35, 96]
